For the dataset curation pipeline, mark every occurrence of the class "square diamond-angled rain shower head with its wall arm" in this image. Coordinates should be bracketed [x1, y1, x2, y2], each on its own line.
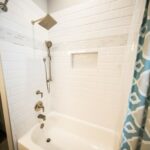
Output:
[31, 14, 57, 30]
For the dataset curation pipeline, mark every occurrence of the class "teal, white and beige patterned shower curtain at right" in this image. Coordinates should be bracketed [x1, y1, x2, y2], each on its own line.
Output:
[121, 0, 150, 150]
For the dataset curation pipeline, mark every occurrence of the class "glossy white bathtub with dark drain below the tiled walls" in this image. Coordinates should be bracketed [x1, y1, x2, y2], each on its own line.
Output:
[18, 113, 118, 150]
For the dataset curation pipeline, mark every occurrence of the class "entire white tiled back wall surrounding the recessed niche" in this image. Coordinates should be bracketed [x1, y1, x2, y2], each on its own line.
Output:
[49, 0, 136, 135]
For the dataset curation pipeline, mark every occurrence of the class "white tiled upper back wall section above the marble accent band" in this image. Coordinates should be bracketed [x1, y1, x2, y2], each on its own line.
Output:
[50, 0, 135, 42]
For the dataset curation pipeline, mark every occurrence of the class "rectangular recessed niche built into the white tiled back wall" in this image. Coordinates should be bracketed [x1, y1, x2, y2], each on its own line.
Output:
[71, 51, 98, 69]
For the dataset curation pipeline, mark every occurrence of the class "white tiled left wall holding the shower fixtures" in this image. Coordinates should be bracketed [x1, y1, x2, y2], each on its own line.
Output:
[0, 0, 49, 146]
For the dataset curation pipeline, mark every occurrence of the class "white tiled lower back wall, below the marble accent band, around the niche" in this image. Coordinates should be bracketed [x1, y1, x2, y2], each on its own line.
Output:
[52, 46, 126, 131]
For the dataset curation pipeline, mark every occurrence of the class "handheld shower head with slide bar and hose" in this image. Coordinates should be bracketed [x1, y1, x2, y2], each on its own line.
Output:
[43, 41, 52, 93]
